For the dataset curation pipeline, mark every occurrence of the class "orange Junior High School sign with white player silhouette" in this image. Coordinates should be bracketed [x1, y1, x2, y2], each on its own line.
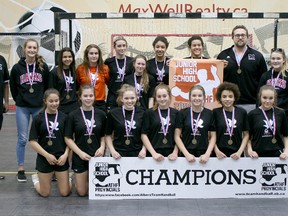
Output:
[169, 59, 224, 109]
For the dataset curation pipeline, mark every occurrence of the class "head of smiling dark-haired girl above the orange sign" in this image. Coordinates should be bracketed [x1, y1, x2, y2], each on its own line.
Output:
[185, 35, 207, 59]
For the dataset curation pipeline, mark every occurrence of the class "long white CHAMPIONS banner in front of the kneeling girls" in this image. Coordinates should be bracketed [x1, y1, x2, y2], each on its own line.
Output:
[89, 157, 288, 200]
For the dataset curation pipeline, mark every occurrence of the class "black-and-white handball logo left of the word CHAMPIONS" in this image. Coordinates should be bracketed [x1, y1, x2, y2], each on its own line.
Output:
[92, 162, 123, 192]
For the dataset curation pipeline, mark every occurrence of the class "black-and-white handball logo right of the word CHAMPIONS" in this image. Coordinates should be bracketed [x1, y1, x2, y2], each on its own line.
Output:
[259, 163, 287, 192]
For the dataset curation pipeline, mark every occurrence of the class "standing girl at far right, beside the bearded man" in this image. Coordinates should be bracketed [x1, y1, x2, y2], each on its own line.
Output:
[259, 48, 288, 117]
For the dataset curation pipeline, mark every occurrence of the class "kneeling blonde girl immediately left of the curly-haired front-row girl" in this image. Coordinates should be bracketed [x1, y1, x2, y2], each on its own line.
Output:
[174, 85, 216, 163]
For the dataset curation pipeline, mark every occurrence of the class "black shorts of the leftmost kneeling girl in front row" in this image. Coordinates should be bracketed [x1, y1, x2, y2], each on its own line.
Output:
[36, 155, 69, 173]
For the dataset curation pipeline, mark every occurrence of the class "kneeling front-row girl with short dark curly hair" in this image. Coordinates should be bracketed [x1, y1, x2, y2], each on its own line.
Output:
[213, 82, 249, 160]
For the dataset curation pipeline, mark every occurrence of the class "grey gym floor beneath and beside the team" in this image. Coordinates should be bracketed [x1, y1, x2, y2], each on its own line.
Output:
[0, 112, 288, 216]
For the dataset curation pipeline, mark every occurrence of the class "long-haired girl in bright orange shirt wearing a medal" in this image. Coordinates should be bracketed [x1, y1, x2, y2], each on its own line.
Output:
[77, 44, 110, 112]
